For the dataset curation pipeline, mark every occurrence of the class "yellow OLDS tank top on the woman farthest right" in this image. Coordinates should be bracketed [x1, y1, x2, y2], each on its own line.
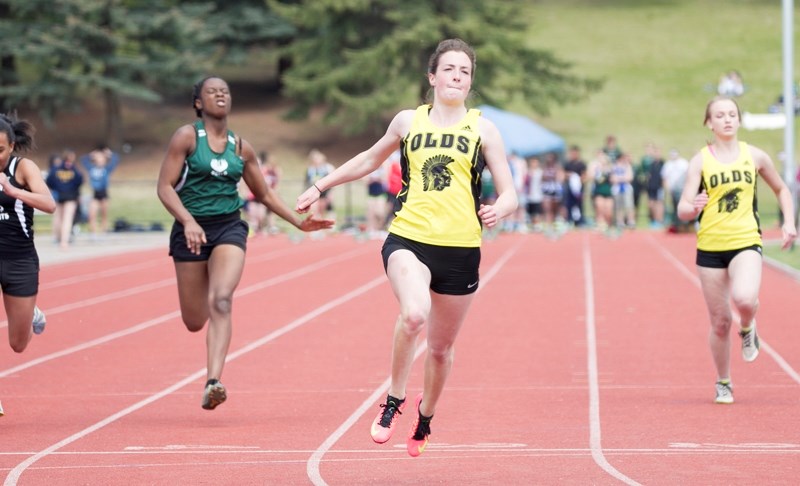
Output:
[697, 142, 761, 251]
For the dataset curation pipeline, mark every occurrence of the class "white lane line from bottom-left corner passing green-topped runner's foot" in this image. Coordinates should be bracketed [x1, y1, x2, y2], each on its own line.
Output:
[3, 275, 386, 486]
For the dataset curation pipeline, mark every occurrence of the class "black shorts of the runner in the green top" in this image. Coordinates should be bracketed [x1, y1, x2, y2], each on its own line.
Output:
[169, 211, 248, 262]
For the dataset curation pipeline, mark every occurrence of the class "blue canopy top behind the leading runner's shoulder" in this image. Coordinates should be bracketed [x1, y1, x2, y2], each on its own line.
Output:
[478, 105, 566, 157]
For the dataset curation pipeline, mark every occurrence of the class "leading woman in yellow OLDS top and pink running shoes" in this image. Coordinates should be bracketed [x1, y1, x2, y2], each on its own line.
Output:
[297, 39, 517, 456]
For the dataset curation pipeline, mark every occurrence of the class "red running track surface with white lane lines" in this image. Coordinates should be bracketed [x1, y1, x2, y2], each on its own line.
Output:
[0, 232, 800, 486]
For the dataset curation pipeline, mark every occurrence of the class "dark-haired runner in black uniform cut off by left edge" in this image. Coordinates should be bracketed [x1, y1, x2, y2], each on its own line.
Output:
[0, 115, 56, 415]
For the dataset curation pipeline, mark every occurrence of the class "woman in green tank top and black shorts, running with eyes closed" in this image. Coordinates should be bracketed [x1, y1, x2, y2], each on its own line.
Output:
[158, 77, 333, 410]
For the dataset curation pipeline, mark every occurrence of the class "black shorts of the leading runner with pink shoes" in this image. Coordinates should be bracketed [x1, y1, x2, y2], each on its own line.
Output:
[381, 233, 481, 295]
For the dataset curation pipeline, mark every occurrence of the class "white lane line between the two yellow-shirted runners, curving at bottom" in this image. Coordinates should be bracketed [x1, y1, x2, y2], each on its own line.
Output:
[583, 236, 639, 485]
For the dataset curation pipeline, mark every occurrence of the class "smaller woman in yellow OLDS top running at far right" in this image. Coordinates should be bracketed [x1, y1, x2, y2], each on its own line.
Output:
[678, 96, 797, 403]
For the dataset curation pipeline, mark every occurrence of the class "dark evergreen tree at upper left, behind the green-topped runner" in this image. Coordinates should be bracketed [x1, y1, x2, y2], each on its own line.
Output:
[0, 0, 294, 147]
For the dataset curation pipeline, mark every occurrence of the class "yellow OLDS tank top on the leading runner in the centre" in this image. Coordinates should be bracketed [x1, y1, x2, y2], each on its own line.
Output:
[389, 105, 485, 247]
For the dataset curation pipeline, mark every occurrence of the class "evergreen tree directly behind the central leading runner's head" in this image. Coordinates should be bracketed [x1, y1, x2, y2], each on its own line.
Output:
[268, 0, 600, 133]
